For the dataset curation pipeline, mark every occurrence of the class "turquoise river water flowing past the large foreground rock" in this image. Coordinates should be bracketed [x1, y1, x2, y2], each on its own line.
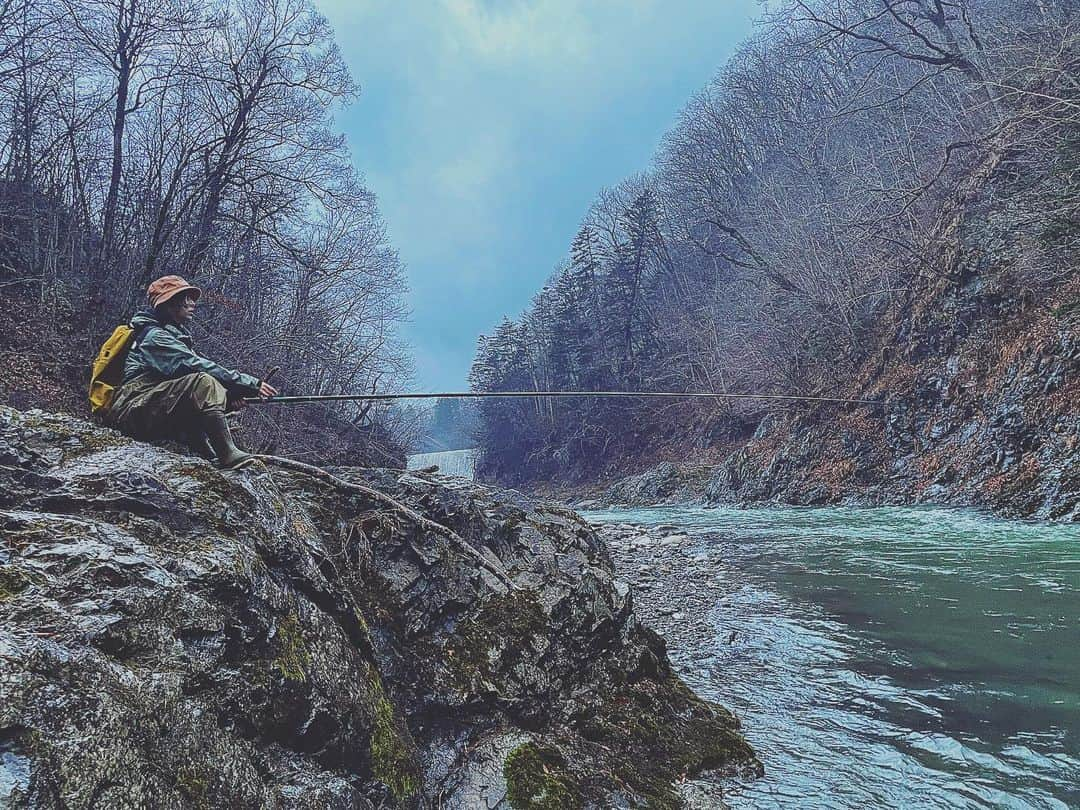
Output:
[586, 508, 1080, 810]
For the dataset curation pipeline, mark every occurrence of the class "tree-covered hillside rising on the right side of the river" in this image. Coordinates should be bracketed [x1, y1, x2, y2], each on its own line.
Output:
[472, 0, 1080, 514]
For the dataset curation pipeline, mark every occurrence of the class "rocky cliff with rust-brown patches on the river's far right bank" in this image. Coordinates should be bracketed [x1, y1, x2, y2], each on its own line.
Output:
[578, 164, 1080, 522]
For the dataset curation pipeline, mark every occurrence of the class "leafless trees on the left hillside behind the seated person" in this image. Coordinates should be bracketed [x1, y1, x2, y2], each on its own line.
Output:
[0, 0, 405, 461]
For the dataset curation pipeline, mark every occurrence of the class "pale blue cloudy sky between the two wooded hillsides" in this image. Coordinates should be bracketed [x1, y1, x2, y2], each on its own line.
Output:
[315, 0, 760, 391]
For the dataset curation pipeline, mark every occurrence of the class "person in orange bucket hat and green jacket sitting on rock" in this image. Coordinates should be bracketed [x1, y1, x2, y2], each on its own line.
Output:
[110, 275, 278, 470]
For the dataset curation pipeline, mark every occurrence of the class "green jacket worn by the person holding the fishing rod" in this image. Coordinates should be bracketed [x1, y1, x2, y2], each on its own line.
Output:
[124, 310, 259, 393]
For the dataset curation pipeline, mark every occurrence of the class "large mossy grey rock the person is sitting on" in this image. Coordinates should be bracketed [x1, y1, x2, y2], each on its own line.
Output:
[0, 408, 760, 809]
